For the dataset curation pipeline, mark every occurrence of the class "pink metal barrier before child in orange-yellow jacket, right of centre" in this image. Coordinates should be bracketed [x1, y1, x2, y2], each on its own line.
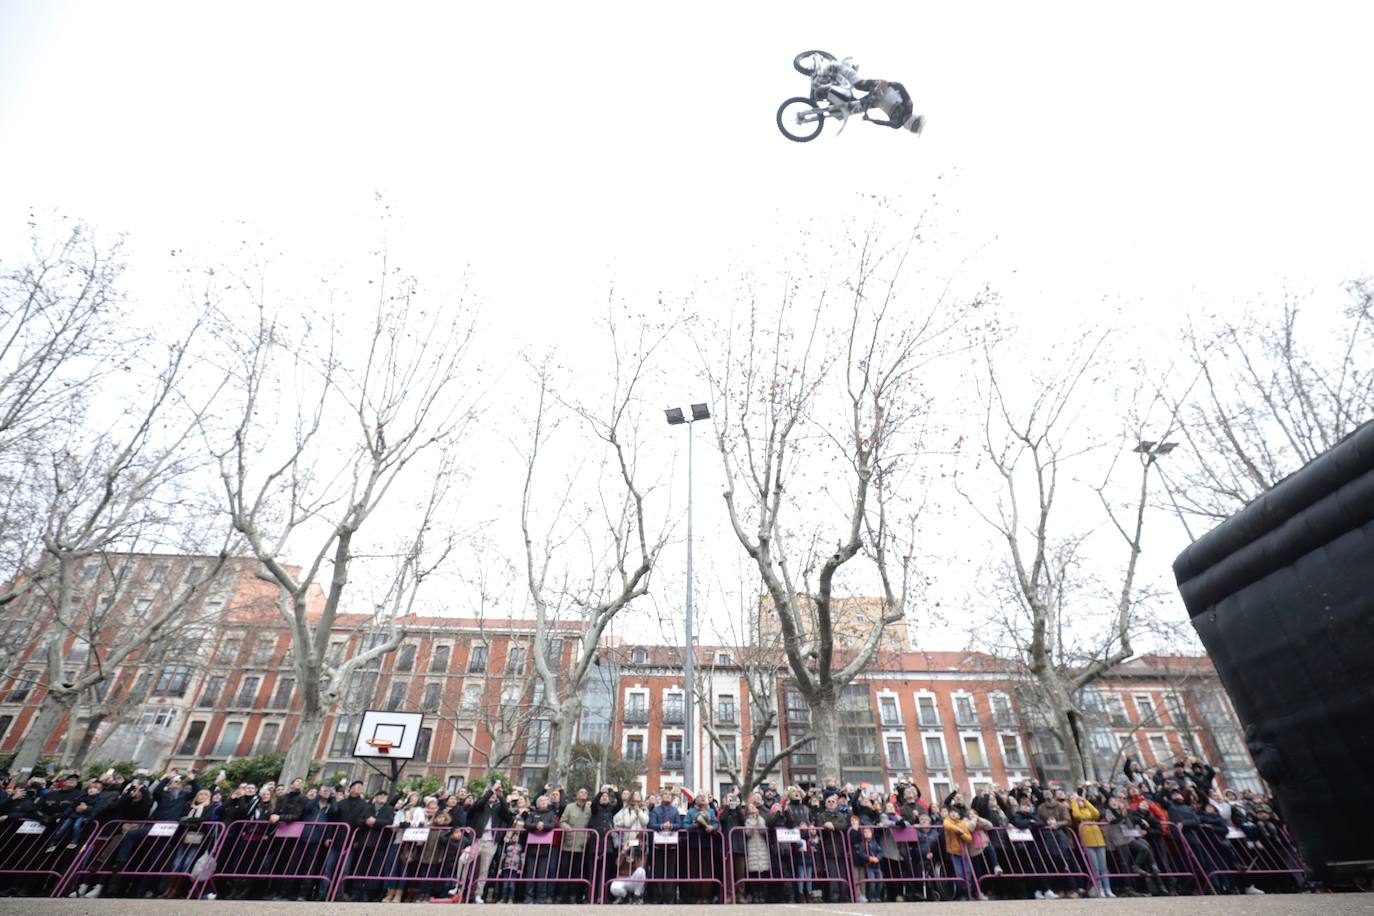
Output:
[849, 825, 972, 902]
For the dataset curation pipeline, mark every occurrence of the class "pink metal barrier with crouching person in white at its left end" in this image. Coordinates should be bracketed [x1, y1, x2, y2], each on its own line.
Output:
[598, 828, 728, 904]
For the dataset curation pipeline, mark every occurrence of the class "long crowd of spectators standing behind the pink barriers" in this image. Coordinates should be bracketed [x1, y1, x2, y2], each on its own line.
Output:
[0, 759, 1282, 904]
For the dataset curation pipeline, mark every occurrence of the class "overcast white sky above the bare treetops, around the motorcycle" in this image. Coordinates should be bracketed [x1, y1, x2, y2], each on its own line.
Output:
[0, 0, 1374, 656]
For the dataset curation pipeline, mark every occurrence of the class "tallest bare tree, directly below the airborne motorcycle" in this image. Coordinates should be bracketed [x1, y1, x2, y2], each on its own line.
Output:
[702, 219, 966, 779]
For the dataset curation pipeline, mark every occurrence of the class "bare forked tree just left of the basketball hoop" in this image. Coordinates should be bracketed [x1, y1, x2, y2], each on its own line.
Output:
[212, 250, 475, 780]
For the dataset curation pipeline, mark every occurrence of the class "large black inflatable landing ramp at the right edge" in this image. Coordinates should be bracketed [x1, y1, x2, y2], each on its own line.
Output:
[1173, 422, 1374, 876]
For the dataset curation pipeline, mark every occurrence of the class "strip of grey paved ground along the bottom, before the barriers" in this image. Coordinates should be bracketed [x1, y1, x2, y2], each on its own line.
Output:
[0, 894, 1374, 916]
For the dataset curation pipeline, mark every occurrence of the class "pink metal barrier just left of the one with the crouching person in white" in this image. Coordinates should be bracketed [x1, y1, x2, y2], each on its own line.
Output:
[459, 827, 600, 904]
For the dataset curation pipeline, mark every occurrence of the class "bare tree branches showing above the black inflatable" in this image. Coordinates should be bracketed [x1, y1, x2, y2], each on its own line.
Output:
[1175, 279, 1374, 519]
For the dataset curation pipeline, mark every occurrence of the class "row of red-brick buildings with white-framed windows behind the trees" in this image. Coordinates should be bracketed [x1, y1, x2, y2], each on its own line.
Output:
[0, 555, 1259, 798]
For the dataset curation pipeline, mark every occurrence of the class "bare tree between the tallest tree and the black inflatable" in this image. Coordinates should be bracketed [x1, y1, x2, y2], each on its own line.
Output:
[959, 338, 1176, 780]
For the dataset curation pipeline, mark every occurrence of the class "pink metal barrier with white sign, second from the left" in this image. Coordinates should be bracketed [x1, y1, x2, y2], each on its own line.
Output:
[54, 821, 224, 897]
